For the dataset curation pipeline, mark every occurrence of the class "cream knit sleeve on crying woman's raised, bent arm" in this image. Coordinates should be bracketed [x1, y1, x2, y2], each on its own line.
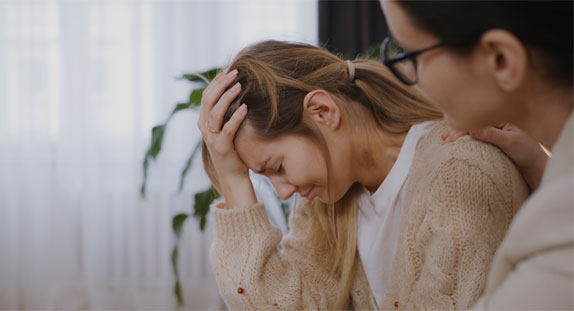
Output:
[210, 199, 337, 310]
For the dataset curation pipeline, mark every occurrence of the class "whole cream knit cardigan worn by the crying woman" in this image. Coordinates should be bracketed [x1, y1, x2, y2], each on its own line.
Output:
[211, 122, 527, 310]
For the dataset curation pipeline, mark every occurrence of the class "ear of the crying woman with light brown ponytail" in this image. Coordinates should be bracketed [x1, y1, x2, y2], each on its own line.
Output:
[303, 89, 341, 129]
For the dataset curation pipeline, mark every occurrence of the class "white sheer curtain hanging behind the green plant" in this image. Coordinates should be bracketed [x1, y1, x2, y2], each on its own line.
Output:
[0, 0, 318, 310]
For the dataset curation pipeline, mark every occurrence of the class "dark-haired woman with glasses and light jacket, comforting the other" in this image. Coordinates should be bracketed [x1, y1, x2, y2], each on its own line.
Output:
[382, 1, 574, 310]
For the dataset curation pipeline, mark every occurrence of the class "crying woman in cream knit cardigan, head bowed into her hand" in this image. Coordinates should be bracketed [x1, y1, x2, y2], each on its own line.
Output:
[198, 41, 527, 310]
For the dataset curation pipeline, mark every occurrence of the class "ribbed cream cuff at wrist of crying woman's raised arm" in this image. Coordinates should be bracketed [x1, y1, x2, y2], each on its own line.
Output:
[211, 203, 273, 239]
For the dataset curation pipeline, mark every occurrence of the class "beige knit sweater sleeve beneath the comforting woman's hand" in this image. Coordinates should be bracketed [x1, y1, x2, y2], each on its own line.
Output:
[384, 141, 527, 310]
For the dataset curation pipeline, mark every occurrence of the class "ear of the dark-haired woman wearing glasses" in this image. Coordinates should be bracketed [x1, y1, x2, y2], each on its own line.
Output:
[480, 29, 528, 92]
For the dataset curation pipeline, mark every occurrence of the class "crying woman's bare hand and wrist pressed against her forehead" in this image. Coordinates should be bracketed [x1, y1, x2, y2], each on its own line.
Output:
[197, 70, 257, 208]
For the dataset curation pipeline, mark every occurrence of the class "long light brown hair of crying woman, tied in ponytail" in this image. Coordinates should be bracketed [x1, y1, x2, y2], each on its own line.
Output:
[202, 41, 442, 309]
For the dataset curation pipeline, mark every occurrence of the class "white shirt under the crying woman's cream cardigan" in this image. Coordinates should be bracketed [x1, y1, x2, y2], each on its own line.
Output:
[357, 121, 434, 305]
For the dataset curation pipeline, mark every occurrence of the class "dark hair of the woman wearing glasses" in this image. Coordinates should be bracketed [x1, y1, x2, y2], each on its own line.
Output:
[399, 0, 574, 86]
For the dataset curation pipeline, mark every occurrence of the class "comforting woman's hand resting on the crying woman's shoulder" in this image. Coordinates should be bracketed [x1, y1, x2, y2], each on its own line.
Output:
[442, 123, 548, 191]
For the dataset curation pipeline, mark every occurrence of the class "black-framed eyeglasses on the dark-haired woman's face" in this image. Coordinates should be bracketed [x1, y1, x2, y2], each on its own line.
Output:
[381, 37, 445, 85]
